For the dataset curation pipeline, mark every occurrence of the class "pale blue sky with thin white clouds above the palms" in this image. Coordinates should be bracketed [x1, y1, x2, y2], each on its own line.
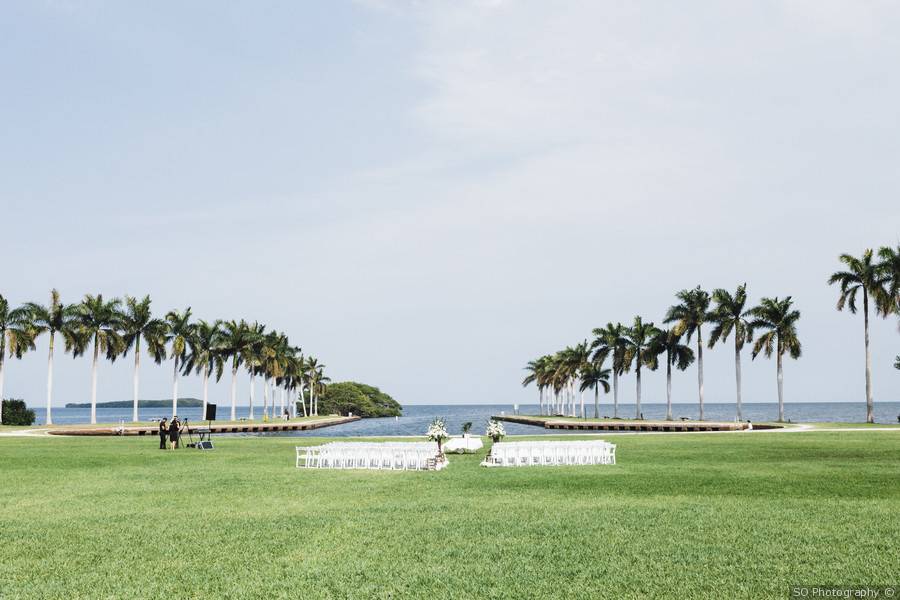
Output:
[0, 0, 900, 406]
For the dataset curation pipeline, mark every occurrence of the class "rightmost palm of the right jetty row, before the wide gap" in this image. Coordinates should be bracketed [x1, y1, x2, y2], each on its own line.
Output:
[750, 296, 801, 422]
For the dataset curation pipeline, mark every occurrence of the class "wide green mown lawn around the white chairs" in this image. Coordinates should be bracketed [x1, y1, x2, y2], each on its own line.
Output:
[0, 432, 900, 599]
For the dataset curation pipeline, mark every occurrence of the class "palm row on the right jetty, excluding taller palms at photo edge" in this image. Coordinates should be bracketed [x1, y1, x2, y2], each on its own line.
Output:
[522, 284, 801, 420]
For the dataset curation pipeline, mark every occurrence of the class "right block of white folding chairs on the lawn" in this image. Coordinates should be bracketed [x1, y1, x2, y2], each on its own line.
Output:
[482, 440, 616, 467]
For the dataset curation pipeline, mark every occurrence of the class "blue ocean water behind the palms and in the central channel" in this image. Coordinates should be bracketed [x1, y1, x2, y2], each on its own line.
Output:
[26, 402, 900, 437]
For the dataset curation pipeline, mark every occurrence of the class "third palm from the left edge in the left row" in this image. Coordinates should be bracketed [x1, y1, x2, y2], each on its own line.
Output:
[73, 294, 125, 424]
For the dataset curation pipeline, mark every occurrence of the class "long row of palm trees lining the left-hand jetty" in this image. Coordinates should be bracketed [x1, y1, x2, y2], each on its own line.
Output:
[0, 290, 330, 425]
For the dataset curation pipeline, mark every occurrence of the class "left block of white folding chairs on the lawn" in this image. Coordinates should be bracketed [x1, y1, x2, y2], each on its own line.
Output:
[296, 442, 443, 471]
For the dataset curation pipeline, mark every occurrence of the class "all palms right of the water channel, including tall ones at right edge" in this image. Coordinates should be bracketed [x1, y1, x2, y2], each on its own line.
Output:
[522, 245, 900, 423]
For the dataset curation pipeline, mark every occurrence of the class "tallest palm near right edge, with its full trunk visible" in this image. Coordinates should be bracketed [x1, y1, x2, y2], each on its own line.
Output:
[828, 248, 889, 423]
